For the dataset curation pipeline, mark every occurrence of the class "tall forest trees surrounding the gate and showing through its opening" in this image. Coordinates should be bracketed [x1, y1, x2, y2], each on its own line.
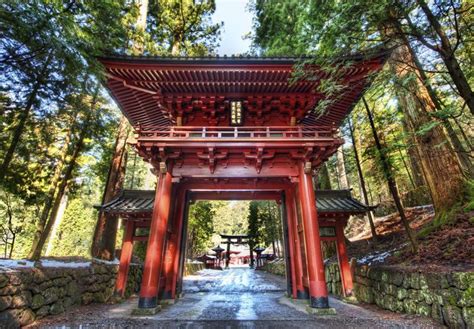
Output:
[0, 0, 474, 258]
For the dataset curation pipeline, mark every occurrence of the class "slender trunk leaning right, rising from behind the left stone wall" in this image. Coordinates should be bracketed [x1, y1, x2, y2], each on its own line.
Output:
[29, 107, 92, 260]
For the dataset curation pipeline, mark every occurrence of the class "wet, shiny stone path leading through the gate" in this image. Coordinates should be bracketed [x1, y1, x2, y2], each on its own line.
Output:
[31, 268, 438, 329]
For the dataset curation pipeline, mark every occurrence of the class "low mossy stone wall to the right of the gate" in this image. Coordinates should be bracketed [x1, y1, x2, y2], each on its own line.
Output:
[326, 264, 474, 328]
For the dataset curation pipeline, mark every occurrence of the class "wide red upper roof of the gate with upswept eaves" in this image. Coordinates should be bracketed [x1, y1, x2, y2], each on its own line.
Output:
[100, 50, 388, 126]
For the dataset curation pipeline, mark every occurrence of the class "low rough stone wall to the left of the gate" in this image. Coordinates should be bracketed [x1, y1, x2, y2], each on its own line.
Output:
[0, 263, 141, 328]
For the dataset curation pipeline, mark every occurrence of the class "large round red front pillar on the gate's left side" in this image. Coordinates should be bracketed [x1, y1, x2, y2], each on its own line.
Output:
[138, 172, 172, 308]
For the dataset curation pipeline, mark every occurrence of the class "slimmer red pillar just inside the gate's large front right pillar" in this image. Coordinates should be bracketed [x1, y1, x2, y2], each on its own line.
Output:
[285, 188, 307, 299]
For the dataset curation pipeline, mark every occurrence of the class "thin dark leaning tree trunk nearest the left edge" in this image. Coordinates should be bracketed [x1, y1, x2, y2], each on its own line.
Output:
[0, 52, 52, 182]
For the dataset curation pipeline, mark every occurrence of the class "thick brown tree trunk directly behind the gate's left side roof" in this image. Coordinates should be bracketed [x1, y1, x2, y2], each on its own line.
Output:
[92, 116, 129, 260]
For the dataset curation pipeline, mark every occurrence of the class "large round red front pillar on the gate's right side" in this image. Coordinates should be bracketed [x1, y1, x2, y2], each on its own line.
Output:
[299, 162, 329, 308]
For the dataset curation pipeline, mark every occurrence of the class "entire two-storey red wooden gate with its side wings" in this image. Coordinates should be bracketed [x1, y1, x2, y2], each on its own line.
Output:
[101, 53, 387, 309]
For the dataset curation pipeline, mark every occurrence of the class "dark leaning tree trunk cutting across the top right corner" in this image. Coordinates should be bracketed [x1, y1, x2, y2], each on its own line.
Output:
[417, 0, 474, 115]
